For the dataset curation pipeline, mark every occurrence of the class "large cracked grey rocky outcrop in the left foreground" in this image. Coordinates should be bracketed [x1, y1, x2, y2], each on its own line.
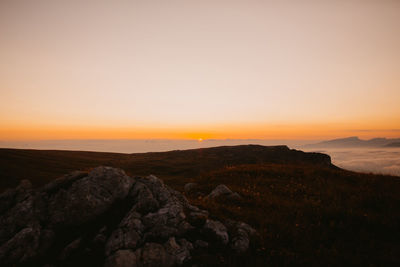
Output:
[0, 167, 256, 266]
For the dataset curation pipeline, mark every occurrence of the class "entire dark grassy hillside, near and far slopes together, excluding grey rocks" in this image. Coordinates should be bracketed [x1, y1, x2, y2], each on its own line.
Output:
[0, 146, 400, 266]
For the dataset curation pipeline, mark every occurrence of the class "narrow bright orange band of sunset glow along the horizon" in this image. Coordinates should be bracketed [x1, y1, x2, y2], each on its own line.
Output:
[0, 120, 400, 142]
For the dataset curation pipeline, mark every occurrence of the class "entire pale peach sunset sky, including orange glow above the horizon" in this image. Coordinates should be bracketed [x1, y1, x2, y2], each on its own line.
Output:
[0, 0, 400, 141]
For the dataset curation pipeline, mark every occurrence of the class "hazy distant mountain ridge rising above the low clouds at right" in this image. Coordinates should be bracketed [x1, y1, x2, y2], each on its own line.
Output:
[304, 136, 400, 148]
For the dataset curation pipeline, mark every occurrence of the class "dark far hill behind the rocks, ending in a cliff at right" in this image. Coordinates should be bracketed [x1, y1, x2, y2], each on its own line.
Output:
[0, 145, 331, 193]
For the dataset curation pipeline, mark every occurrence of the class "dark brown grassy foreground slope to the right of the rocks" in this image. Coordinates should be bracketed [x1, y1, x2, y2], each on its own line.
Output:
[189, 164, 400, 266]
